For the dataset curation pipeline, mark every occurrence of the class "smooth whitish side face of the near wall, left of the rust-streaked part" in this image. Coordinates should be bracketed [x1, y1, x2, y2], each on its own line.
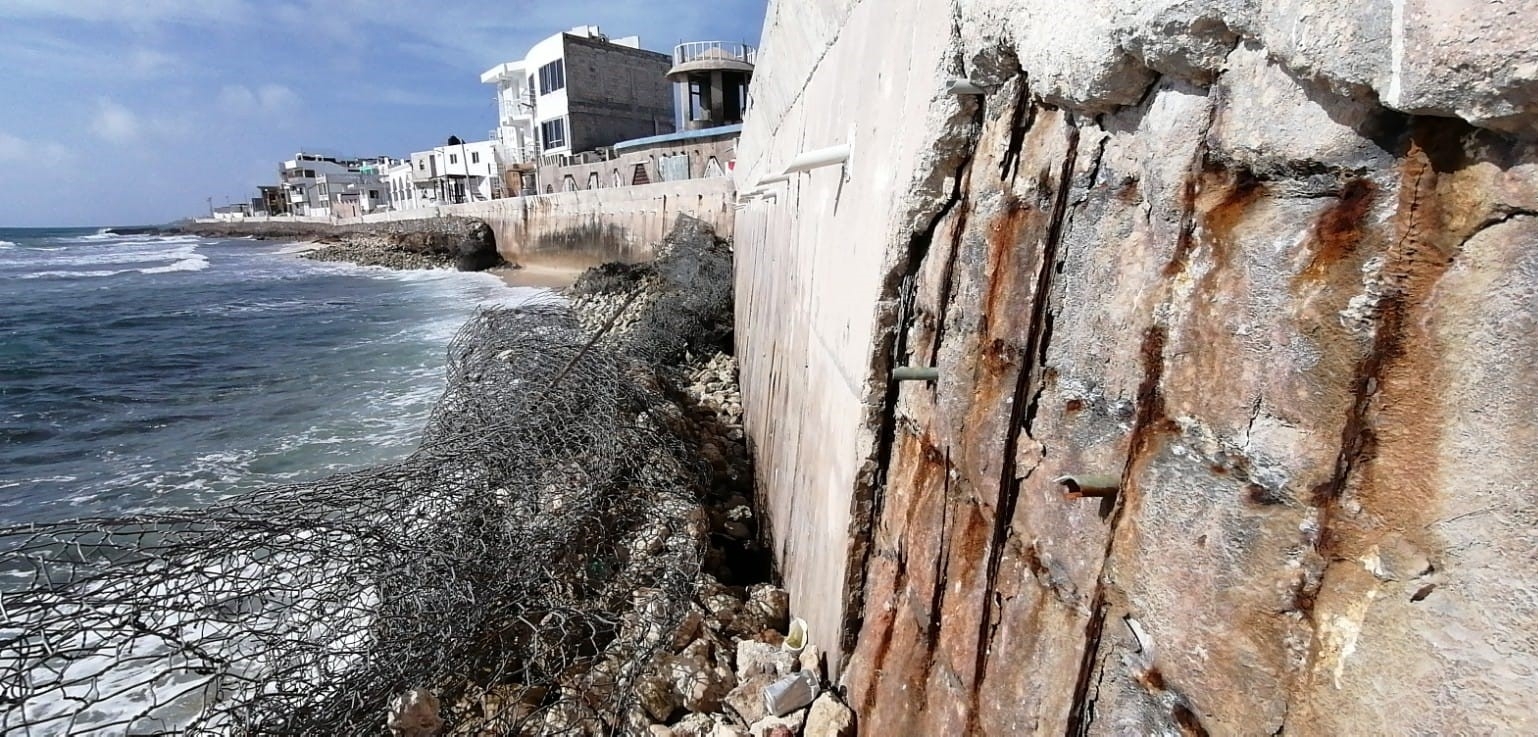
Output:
[722, 0, 960, 683]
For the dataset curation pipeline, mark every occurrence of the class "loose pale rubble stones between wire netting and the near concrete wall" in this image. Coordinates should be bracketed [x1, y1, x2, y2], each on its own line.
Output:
[553, 220, 854, 737]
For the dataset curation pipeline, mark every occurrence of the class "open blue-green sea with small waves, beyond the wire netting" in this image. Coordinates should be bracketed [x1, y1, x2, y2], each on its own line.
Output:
[0, 229, 531, 525]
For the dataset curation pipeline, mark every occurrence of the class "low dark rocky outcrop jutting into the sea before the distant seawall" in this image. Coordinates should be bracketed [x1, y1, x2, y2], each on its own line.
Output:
[303, 217, 503, 271]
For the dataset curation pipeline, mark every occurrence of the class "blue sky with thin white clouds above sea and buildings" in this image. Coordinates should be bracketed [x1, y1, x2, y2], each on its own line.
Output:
[0, 0, 766, 228]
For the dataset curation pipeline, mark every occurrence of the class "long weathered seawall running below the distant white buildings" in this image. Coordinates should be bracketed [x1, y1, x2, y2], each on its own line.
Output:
[352, 177, 734, 263]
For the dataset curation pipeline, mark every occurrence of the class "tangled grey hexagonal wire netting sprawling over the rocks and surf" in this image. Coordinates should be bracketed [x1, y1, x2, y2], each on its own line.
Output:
[0, 229, 731, 735]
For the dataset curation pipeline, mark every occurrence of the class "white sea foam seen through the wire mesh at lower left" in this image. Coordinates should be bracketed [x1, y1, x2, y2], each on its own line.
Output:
[0, 547, 380, 737]
